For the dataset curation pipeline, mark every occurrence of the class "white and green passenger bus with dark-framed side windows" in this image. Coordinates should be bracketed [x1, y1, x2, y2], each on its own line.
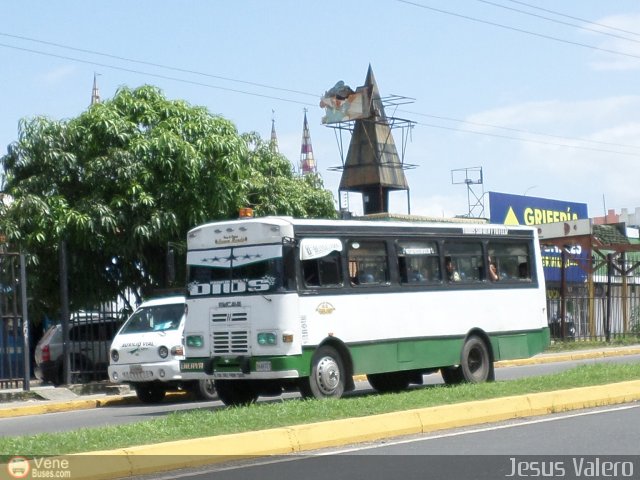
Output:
[182, 217, 549, 405]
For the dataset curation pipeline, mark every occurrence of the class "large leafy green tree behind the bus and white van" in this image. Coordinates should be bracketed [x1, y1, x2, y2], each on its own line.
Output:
[0, 86, 335, 318]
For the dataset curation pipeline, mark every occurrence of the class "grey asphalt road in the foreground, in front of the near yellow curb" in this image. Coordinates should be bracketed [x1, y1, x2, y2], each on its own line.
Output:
[135, 403, 640, 480]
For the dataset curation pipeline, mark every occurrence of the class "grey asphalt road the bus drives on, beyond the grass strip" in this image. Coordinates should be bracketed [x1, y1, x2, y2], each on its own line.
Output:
[0, 355, 640, 436]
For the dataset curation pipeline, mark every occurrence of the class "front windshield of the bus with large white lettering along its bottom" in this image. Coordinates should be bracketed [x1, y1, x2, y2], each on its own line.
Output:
[187, 245, 284, 296]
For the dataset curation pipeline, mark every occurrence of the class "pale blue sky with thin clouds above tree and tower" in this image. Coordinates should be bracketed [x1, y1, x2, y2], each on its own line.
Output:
[0, 0, 640, 217]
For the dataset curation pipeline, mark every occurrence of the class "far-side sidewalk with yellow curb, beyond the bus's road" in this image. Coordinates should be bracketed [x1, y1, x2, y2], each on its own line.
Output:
[0, 345, 640, 418]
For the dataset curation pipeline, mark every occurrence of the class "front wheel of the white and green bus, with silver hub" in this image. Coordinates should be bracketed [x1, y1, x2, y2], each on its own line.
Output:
[301, 345, 345, 398]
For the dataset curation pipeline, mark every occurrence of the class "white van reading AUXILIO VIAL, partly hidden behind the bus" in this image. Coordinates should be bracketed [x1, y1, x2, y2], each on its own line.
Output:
[109, 296, 217, 403]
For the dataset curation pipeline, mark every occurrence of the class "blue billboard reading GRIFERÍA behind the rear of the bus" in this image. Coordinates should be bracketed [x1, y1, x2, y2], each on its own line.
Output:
[489, 192, 591, 282]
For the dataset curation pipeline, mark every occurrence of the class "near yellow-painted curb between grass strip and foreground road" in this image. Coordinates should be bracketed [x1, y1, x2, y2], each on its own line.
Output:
[20, 380, 640, 479]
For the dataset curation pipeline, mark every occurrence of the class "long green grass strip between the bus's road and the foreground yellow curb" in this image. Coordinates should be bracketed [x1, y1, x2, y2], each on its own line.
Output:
[0, 363, 640, 461]
